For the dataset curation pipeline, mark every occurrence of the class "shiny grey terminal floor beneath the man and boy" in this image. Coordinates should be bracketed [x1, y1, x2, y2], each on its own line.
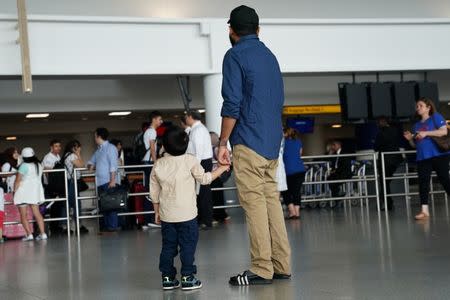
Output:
[0, 201, 450, 300]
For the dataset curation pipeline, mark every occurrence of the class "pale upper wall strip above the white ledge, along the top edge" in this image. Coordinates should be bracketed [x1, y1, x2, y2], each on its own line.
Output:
[0, 0, 450, 18]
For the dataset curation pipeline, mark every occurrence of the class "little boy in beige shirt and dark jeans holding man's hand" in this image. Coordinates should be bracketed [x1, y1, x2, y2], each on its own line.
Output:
[150, 127, 229, 290]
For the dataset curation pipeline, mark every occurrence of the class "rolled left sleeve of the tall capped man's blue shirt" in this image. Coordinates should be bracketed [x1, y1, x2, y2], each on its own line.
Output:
[221, 51, 243, 120]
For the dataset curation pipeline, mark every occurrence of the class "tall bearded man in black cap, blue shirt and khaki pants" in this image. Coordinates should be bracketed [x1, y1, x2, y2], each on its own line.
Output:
[218, 5, 291, 285]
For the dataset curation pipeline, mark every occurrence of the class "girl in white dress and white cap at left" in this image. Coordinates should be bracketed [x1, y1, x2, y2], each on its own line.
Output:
[14, 147, 47, 241]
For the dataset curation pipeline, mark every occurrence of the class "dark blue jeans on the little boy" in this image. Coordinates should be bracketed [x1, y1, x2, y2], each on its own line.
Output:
[159, 218, 198, 277]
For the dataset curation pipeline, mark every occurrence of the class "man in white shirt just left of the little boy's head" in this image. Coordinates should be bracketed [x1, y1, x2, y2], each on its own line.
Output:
[142, 110, 163, 228]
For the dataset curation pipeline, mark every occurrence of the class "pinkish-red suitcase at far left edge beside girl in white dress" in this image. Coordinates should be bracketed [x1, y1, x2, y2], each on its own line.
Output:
[3, 194, 34, 239]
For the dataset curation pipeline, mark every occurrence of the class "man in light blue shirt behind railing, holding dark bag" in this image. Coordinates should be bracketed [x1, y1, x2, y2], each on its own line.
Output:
[87, 128, 119, 232]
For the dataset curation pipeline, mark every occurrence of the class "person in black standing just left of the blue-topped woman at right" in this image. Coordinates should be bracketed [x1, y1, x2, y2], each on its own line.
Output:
[374, 117, 403, 210]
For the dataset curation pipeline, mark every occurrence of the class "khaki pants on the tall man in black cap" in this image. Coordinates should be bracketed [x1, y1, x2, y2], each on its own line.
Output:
[233, 145, 291, 279]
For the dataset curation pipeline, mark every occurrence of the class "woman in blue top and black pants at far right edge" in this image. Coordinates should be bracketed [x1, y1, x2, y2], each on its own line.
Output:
[404, 98, 450, 220]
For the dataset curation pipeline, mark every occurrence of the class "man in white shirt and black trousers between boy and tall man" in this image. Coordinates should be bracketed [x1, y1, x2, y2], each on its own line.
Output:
[185, 111, 214, 229]
